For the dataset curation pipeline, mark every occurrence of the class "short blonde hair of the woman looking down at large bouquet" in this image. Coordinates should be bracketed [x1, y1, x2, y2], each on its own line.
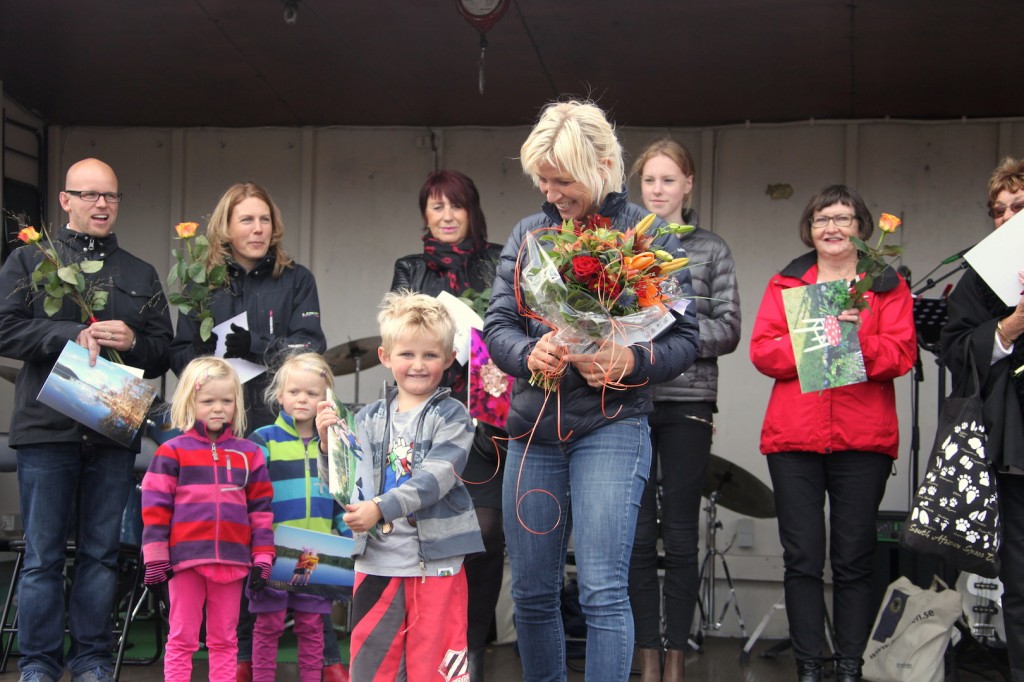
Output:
[519, 99, 626, 206]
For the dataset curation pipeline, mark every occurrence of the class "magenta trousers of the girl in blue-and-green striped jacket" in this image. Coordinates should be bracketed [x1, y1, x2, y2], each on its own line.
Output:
[253, 608, 324, 682]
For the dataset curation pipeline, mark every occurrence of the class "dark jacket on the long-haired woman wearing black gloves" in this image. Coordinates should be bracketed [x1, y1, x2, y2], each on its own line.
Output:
[171, 256, 327, 431]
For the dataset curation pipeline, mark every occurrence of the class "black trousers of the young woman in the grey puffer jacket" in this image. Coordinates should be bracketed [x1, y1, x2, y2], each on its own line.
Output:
[630, 401, 715, 649]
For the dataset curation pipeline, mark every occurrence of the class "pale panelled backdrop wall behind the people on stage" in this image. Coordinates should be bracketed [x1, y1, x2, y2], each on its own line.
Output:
[0, 114, 1024, 636]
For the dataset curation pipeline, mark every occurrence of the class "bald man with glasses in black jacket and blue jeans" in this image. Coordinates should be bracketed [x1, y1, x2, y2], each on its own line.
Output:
[0, 159, 173, 682]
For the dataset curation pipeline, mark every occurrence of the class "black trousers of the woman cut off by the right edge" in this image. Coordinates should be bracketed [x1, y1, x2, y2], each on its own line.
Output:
[998, 474, 1024, 682]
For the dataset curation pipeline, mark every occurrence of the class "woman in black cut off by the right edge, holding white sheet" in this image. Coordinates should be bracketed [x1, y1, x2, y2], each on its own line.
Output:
[940, 158, 1024, 680]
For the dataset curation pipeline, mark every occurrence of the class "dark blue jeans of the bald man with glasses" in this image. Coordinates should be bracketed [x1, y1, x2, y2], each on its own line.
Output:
[17, 443, 135, 679]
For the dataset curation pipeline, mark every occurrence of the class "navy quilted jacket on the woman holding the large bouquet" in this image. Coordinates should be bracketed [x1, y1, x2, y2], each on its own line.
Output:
[483, 191, 698, 442]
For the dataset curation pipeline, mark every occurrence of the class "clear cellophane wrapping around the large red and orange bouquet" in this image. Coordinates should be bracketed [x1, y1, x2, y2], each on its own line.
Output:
[519, 229, 689, 353]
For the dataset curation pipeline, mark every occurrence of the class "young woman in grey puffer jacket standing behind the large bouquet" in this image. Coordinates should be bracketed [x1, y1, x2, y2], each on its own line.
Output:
[630, 139, 739, 682]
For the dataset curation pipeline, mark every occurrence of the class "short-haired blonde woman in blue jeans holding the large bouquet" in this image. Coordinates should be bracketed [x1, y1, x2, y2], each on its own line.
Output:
[484, 100, 697, 682]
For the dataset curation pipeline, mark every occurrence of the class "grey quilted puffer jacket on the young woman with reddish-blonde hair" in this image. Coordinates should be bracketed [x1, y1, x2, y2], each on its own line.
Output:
[654, 209, 739, 402]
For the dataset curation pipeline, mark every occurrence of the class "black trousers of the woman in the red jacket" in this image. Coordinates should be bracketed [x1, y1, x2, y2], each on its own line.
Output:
[768, 452, 893, 660]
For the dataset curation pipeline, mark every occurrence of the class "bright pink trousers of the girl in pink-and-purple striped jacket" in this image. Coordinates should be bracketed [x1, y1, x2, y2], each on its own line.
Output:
[164, 568, 244, 682]
